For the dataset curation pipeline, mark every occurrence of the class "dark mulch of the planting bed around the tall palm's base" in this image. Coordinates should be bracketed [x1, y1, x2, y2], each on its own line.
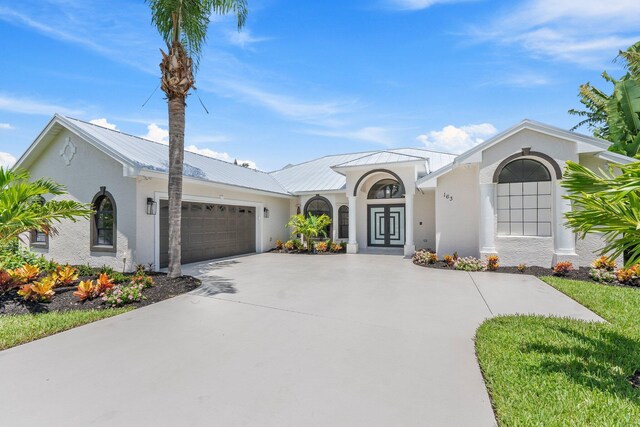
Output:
[0, 273, 200, 315]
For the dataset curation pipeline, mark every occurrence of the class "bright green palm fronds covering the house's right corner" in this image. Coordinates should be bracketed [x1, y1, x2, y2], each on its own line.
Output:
[561, 162, 640, 267]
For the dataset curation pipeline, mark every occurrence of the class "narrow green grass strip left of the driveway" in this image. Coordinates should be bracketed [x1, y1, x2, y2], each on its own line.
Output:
[0, 308, 131, 350]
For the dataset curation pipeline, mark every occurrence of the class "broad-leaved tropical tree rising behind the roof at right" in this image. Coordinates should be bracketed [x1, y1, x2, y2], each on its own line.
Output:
[569, 42, 640, 157]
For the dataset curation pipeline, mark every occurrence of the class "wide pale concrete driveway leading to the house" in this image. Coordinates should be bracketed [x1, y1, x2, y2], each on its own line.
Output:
[0, 254, 600, 426]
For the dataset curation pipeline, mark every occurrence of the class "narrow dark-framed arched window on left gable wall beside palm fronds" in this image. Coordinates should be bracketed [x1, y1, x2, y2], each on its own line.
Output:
[91, 187, 117, 252]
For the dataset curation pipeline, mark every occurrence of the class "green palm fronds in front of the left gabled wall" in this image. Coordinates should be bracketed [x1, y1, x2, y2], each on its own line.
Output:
[0, 167, 93, 245]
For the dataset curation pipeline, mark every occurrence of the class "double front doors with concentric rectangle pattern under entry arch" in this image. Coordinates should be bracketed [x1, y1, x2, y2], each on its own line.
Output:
[367, 205, 405, 247]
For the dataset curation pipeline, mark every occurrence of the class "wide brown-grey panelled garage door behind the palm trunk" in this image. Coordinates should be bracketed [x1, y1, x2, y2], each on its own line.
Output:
[159, 200, 256, 267]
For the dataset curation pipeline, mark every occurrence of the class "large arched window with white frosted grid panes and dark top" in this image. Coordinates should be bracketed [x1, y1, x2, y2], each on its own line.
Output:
[498, 159, 551, 237]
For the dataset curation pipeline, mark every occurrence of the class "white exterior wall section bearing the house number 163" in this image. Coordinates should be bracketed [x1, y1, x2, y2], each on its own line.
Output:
[435, 164, 480, 257]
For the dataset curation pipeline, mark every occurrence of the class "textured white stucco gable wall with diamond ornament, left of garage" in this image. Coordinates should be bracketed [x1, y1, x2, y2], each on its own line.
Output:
[29, 130, 136, 270]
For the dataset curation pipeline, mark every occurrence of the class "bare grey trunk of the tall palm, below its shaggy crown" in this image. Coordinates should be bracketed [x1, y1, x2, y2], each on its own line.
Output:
[168, 96, 185, 277]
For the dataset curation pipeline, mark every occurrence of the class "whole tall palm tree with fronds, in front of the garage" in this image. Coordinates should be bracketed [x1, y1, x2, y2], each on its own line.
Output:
[146, 0, 248, 277]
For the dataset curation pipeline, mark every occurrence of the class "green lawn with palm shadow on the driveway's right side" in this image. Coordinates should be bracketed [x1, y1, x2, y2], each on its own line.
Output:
[476, 277, 640, 426]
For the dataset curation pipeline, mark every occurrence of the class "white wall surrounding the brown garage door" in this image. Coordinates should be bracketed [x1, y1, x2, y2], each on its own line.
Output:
[136, 177, 291, 266]
